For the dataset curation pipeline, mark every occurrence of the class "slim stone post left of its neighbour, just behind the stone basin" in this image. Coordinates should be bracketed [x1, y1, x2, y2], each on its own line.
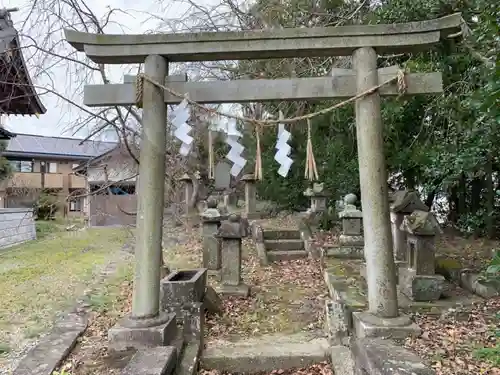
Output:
[201, 199, 222, 277]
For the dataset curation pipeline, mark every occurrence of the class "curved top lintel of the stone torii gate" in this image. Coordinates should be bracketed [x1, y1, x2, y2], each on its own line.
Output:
[65, 13, 463, 64]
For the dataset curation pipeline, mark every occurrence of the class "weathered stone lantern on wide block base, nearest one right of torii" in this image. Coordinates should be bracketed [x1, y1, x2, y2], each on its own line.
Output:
[399, 210, 445, 301]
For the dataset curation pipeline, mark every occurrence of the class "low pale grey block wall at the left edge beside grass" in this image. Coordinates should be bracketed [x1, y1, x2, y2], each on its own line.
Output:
[0, 208, 36, 249]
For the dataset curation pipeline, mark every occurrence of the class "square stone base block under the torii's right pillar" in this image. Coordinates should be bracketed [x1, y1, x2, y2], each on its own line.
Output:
[352, 311, 422, 339]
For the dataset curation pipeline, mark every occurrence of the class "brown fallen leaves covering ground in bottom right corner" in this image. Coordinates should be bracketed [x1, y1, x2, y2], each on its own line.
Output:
[405, 298, 500, 375]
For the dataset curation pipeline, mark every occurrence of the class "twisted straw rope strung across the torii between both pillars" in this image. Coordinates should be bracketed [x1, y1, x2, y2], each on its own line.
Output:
[135, 70, 407, 126]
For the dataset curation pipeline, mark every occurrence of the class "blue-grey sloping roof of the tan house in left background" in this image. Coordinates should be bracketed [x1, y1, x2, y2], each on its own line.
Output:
[3, 134, 117, 160]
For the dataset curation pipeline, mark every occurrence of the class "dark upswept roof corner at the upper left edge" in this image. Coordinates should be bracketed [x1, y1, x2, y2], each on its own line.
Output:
[0, 9, 47, 115]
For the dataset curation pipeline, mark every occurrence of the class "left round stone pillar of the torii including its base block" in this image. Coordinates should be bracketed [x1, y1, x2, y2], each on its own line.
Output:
[108, 55, 176, 350]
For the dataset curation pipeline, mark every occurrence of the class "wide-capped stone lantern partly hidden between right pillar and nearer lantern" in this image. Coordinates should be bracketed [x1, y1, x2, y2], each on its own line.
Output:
[389, 190, 429, 275]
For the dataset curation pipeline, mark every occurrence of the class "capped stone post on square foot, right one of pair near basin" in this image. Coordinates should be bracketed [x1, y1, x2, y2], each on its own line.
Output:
[217, 214, 250, 297]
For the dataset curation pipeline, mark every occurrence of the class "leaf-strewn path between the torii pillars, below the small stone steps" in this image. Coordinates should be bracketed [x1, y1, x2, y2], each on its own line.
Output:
[205, 239, 327, 339]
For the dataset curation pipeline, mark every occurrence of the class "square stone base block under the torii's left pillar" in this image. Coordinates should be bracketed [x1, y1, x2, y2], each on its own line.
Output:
[108, 312, 177, 351]
